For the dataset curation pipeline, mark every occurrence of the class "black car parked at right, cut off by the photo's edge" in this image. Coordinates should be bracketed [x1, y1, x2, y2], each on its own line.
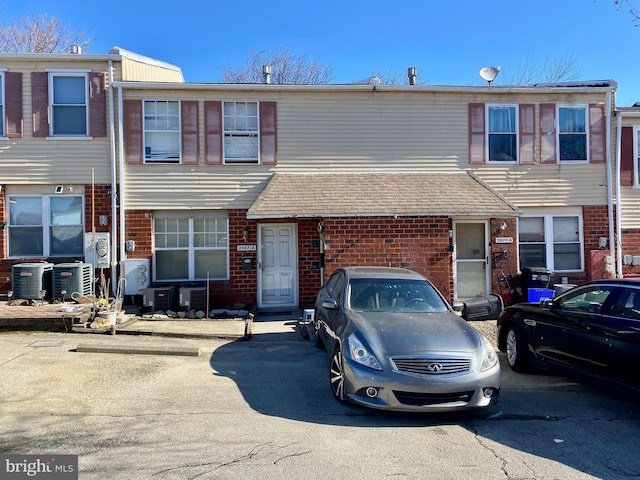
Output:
[497, 279, 640, 393]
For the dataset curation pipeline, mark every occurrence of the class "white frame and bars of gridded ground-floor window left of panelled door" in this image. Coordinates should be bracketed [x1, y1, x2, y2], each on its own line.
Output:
[152, 211, 230, 282]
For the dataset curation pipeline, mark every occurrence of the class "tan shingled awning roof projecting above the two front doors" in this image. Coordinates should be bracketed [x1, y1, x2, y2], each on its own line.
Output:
[247, 172, 520, 220]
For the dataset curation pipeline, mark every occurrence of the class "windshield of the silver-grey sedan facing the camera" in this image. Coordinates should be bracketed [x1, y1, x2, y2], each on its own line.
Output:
[348, 278, 449, 312]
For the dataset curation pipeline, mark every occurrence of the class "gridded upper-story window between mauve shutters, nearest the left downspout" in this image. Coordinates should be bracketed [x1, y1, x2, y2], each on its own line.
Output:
[144, 100, 181, 163]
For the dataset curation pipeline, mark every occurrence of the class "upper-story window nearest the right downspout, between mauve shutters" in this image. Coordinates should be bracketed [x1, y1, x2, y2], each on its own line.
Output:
[558, 105, 589, 162]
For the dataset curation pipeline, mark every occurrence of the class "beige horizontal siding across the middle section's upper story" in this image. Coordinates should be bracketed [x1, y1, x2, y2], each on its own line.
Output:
[119, 90, 607, 210]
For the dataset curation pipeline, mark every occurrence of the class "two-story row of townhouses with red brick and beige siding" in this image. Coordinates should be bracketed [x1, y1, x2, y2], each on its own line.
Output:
[0, 49, 640, 308]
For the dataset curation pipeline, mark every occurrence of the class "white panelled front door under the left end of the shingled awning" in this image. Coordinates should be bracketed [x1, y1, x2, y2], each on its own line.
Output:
[258, 223, 298, 307]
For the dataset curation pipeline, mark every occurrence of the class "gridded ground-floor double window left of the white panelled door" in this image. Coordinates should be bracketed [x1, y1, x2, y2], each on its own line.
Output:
[153, 212, 229, 281]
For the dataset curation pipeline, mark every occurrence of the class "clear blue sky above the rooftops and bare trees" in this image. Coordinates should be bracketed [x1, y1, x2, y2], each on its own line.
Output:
[0, 0, 640, 106]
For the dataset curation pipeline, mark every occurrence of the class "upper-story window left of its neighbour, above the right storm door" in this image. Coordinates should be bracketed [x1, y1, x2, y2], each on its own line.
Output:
[487, 105, 518, 162]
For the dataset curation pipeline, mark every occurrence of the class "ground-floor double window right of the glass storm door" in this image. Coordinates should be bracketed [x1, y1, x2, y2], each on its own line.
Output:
[518, 215, 584, 272]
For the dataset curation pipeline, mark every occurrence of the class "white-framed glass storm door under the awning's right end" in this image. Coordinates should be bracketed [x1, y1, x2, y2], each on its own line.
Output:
[453, 220, 491, 300]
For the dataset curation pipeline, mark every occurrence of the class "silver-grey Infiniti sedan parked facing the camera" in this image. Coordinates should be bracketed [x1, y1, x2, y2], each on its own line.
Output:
[314, 267, 500, 412]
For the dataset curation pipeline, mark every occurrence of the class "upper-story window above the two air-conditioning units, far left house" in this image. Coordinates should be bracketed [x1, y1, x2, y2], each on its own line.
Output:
[49, 73, 89, 137]
